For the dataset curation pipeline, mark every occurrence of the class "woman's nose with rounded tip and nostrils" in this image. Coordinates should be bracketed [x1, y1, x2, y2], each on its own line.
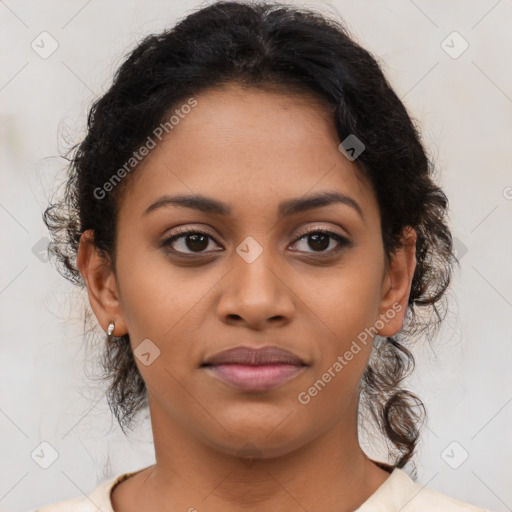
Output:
[217, 246, 295, 330]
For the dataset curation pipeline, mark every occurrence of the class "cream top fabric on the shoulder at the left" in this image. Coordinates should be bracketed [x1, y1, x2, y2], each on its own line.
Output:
[33, 472, 135, 512]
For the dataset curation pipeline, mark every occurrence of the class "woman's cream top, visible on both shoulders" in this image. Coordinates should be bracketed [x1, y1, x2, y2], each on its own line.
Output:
[34, 468, 491, 512]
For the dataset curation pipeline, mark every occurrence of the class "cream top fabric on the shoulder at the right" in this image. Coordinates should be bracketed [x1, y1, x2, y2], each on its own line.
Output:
[357, 468, 490, 512]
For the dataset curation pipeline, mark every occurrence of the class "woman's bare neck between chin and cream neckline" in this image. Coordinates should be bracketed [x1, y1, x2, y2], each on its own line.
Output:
[116, 392, 389, 512]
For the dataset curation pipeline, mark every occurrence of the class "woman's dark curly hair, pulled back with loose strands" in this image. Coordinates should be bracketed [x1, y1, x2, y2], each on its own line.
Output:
[43, 1, 458, 476]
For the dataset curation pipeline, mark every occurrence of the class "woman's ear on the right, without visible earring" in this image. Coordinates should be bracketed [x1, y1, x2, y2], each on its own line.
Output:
[376, 226, 417, 337]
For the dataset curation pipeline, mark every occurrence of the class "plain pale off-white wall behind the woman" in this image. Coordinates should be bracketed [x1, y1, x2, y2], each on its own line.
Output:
[0, 0, 512, 512]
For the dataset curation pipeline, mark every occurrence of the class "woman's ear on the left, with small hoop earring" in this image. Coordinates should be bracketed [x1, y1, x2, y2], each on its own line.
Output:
[76, 229, 128, 336]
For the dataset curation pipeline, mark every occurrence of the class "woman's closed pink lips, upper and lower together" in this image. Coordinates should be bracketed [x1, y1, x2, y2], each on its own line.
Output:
[201, 346, 308, 392]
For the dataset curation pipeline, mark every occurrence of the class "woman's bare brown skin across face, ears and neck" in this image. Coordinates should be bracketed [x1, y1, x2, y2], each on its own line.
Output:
[77, 84, 416, 512]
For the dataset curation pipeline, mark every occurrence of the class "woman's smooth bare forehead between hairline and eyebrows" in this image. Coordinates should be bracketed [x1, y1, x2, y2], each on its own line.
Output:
[118, 84, 376, 224]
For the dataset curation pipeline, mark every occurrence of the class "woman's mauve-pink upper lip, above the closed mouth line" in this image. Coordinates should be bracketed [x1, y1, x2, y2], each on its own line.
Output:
[202, 346, 306, 366]
